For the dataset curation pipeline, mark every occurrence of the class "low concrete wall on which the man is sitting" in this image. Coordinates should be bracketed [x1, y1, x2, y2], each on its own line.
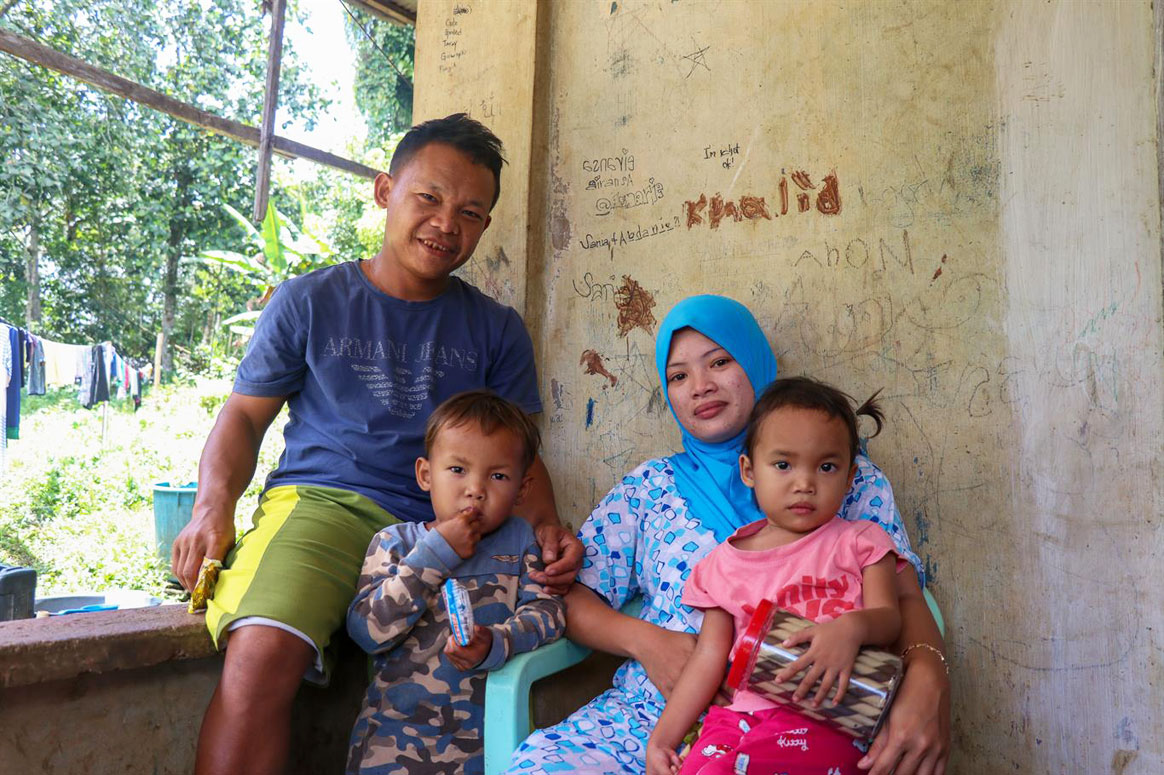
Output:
[0, 605, 620, 775]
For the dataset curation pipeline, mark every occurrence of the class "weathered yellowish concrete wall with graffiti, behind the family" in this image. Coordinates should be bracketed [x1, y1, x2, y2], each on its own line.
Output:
[417, 0, 1164, 774]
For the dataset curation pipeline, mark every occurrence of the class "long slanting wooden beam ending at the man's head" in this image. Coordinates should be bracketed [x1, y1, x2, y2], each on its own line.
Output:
[0, 29, 379, 178]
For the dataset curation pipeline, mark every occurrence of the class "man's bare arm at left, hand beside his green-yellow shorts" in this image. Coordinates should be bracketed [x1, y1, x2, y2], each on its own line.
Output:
[171, 393, 286, 589]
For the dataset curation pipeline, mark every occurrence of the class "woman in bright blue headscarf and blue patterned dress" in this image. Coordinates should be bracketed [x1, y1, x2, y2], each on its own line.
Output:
[509, 296, 949, 775]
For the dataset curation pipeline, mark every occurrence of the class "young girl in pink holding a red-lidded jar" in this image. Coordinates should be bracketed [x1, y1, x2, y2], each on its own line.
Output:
[647, 377, 907, 775]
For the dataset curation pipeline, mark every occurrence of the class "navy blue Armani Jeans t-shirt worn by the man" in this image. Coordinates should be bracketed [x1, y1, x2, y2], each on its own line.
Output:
[234, 262, 541, 521]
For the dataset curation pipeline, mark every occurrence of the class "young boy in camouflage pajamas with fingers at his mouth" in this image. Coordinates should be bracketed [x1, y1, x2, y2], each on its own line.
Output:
[347, 390, 566, 775]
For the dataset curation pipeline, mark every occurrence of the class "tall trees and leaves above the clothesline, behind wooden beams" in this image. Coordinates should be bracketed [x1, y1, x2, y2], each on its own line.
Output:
[0, 0, 413, 371]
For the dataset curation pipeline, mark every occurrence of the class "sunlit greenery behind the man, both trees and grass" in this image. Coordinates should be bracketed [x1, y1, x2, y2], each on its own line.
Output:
[0, 0, 413, 596]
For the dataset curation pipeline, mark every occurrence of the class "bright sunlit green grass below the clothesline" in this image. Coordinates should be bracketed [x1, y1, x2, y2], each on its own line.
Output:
[0, 379, 285, 597]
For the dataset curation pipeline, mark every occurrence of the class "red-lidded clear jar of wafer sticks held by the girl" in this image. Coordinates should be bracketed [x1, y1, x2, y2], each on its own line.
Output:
[728, 600, 902, 741]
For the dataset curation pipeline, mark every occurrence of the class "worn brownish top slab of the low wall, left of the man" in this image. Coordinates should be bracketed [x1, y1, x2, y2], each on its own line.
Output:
[0, 603, 215, 689]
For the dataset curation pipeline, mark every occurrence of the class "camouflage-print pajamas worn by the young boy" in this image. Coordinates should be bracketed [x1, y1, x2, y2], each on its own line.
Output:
[347, 518, 566, 775]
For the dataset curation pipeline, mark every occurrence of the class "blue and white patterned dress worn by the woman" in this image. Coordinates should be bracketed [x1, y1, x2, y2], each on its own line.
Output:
[508, 455, 924, 775]
